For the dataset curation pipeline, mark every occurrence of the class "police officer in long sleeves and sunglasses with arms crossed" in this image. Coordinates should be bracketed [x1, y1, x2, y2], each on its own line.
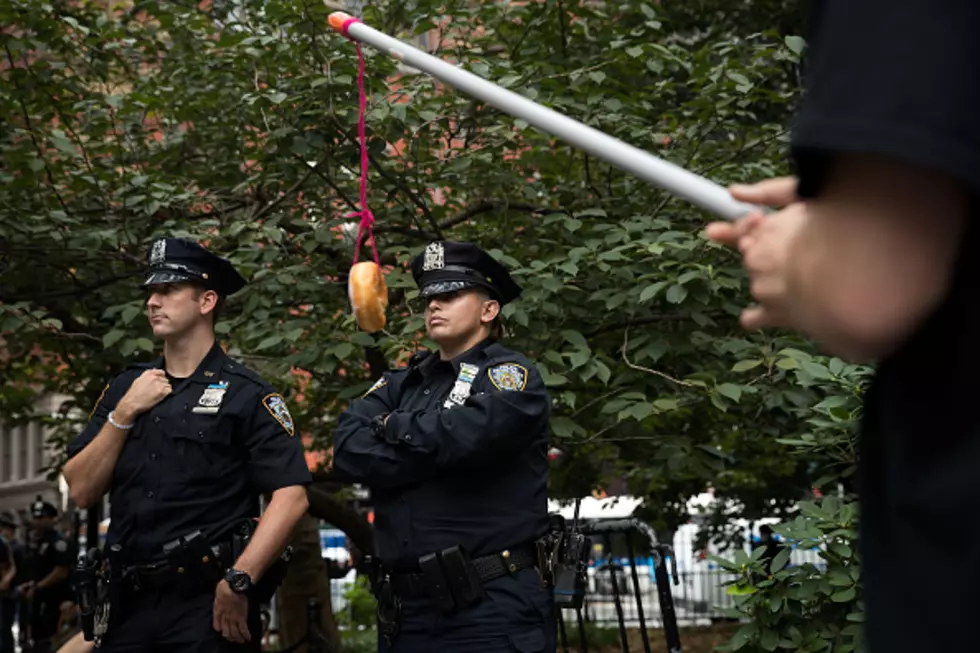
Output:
[333, 242, 555, 653]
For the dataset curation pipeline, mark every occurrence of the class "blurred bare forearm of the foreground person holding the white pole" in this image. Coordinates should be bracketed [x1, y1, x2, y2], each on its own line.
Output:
[789, 158, 966, 361]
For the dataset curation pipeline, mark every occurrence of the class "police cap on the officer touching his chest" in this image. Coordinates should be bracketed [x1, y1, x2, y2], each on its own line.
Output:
[143, 238, 245, 297]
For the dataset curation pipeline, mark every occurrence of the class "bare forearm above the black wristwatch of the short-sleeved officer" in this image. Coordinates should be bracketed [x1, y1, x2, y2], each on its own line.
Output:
[235, 485, 309, 582]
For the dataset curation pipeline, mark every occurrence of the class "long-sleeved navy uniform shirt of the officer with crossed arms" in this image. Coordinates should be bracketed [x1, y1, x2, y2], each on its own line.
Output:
[333, 341, 551, 570]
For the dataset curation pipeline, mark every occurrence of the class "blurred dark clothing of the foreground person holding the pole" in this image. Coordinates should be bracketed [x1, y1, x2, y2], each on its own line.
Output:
[793, 0, 980, 653]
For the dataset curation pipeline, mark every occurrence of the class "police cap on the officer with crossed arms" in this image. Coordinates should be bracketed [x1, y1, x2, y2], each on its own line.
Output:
[412, 241, 521, 305]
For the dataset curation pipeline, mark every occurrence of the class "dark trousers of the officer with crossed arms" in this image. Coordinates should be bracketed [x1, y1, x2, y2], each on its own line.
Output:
[378, 569, 556, 653]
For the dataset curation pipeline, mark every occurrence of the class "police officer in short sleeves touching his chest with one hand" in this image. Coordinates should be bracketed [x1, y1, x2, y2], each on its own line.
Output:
[64, 238, 311, 653]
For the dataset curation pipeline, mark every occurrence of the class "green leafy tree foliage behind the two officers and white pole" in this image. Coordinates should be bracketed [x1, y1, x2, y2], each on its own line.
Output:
[0, 0, 868, 644]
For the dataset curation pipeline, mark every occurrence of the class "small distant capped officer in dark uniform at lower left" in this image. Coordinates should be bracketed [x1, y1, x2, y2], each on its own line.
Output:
[19, 496, 71, 653]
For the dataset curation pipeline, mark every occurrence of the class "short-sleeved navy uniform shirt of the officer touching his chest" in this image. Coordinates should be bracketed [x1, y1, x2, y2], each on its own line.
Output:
[68, 341, 312, 562]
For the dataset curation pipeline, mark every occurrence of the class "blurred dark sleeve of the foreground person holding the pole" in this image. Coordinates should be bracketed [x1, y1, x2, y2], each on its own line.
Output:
[792, 0, 980, 197]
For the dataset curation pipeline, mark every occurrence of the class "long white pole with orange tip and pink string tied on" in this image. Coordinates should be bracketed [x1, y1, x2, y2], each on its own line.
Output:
[330, 11, 759, 220]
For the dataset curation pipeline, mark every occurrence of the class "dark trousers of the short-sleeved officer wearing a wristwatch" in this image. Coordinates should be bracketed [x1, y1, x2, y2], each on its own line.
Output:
[98, 589, 262, 653]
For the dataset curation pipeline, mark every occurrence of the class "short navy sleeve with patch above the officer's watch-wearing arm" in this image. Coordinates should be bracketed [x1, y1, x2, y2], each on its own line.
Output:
[244, 386, 313, 492]
